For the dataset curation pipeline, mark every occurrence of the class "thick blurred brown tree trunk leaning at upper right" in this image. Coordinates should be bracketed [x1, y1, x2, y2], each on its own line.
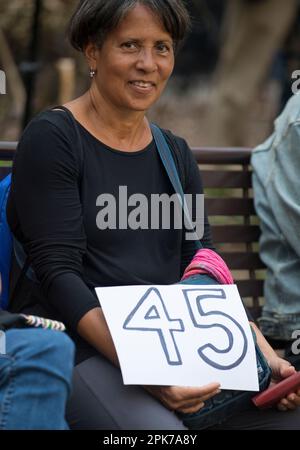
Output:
[203, 0, 299, 147]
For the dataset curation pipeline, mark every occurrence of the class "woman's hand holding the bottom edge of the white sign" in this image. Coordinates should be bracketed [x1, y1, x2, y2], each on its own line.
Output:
[144, 383, 220, 414]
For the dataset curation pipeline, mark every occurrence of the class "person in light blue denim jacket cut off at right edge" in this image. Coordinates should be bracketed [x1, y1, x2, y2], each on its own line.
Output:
[251, 94, 300, 367]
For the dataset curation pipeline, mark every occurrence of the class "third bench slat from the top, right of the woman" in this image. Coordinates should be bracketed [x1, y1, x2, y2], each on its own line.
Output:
[205, 197, 255, 216]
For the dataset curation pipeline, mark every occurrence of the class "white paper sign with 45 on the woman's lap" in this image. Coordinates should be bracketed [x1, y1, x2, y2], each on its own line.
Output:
[96, 284, 258, 391]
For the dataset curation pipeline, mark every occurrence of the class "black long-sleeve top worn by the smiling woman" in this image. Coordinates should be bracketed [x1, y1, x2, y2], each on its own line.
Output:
[7, 111, 212, 359]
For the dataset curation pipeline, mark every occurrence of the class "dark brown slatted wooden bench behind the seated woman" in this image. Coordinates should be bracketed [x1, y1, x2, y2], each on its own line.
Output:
[0, 142, 264, 318]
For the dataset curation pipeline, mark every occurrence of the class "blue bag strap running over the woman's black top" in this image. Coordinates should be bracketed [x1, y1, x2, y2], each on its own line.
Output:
[151, 124, 203, 250]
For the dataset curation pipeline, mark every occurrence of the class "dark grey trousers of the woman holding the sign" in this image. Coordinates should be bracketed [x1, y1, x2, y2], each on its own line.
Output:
[67, 354, 300, 430]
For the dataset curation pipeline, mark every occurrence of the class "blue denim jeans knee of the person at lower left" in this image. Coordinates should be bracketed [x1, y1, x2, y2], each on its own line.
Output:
[0, 329, 74, 430]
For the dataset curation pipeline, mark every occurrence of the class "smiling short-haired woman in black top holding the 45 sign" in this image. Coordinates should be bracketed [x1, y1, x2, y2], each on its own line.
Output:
[8, 0, 299, 429]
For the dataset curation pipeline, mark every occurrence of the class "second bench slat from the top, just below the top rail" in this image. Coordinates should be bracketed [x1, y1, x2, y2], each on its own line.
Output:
[201, 170, 252, 189]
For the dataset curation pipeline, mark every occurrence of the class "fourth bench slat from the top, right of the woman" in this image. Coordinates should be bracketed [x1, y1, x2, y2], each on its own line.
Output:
[211, 225, 260, 244]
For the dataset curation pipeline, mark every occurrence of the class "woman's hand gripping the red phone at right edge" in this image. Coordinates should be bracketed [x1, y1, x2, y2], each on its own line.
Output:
[268, 356, 300, 411]
